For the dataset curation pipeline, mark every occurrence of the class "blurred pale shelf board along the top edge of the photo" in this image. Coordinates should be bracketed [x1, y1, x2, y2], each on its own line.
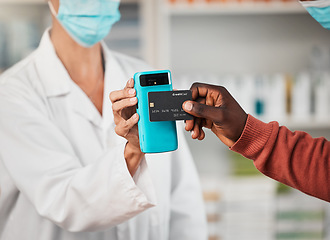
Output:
[163, 1, 306, 16]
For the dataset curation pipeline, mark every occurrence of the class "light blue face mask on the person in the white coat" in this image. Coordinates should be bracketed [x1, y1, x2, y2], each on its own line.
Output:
[48, 0, 120, 47]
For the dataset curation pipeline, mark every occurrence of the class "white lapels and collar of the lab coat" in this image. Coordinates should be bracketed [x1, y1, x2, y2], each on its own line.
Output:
[36, 29, 128, 129]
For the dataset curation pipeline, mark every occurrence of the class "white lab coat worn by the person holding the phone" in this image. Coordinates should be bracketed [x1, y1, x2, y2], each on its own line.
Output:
[0, 31, 207, 240]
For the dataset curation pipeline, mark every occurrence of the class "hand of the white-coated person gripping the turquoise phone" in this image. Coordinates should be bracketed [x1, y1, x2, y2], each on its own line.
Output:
[110, 79, 144, 176]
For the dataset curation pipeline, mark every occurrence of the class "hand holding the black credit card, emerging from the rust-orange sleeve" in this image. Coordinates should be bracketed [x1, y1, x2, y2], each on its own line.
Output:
[182, 83, 247, 147]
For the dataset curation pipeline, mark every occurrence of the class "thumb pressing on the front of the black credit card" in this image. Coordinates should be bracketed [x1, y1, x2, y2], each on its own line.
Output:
[182, 101, 223, 122]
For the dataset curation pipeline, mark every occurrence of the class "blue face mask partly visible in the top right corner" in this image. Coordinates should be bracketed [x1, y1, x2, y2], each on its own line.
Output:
[301, 0, 330, 30]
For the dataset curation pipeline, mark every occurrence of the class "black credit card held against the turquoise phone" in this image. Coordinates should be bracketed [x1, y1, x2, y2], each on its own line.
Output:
[148, 90, 193, 122]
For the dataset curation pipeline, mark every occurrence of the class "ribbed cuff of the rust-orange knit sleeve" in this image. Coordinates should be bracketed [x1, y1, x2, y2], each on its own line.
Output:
[230, 115, 275, 160]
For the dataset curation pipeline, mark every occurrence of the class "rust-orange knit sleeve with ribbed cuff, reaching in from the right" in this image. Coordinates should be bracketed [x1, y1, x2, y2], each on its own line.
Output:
[230, 115, 330, 202]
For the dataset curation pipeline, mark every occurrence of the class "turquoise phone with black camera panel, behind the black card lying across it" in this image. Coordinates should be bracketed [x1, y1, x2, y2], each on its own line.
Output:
[134, 70, 178, 153]
